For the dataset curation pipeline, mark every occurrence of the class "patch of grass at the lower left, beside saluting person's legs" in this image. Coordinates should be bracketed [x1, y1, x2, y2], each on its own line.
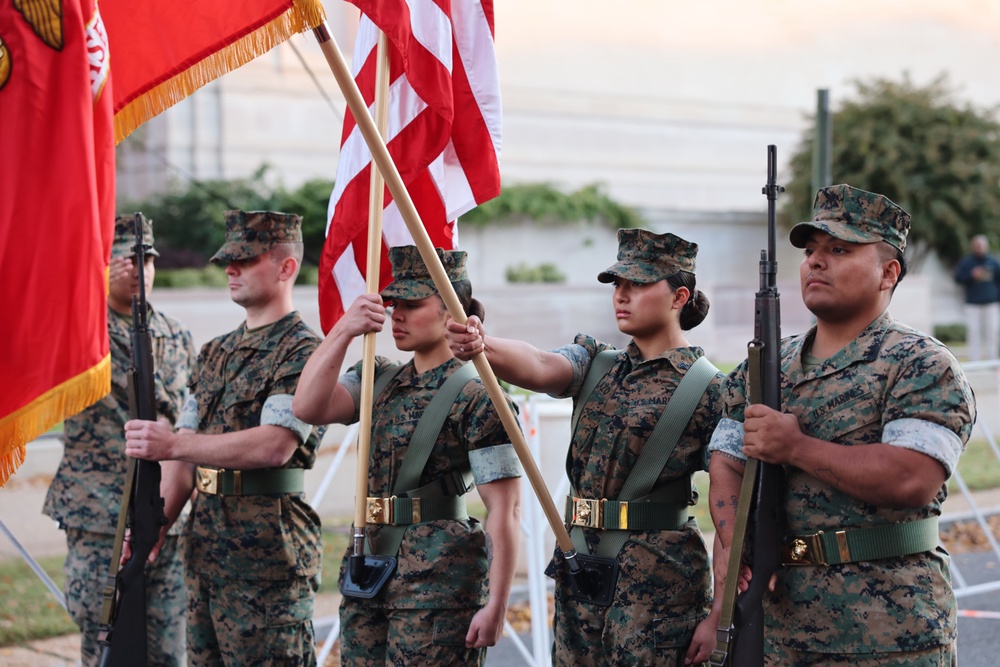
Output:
[0, 556, 77, 646]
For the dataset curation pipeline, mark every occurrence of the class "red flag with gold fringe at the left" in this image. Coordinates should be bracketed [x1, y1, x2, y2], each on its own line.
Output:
[0, 0, 325, 486]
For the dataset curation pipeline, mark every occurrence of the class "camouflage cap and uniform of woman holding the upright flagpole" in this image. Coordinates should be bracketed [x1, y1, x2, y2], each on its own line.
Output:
[340, 246, 521, 667]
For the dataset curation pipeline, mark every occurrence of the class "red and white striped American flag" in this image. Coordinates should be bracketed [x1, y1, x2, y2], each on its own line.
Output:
[319, 0, 501, 333]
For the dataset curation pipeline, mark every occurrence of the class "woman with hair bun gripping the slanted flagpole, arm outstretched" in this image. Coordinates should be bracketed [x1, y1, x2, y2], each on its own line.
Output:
[452, 229, 723, 667]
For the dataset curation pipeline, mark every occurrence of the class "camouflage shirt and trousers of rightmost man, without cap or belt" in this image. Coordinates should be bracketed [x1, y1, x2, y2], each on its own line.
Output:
[712, 313, 975, 664]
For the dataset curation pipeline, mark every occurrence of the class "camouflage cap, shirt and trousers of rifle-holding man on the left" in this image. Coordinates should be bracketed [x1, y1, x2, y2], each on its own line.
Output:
[178, 211, 324, 667]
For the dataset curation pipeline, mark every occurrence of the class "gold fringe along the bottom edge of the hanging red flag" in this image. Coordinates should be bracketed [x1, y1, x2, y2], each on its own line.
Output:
[0, 354, 111, 486]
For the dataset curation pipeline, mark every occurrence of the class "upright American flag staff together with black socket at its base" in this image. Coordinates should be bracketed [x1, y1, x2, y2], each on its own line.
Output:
[341, 30, 396, 598]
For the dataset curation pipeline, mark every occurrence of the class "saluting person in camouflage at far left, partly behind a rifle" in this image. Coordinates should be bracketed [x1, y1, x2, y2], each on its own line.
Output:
[42, 215, 195, 667]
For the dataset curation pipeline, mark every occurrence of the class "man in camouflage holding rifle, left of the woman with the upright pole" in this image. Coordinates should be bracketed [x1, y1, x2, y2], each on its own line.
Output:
[120, 211, 322, 667]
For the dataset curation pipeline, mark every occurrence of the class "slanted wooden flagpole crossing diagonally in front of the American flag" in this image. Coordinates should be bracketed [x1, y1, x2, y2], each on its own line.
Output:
[313, 23, 591, 589]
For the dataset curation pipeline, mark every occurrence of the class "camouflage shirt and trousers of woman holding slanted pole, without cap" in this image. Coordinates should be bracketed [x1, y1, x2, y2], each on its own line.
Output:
[546, 334, 722, 667]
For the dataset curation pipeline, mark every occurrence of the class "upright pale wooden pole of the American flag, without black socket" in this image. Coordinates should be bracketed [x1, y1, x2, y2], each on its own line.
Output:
[354, 30, 389, 568]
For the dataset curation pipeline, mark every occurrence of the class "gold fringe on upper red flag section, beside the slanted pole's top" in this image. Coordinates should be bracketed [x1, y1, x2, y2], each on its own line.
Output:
[112, 0, 326, 145]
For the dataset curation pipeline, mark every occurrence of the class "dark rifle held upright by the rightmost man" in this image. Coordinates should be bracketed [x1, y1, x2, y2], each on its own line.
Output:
[710, 145, 785, 667]
